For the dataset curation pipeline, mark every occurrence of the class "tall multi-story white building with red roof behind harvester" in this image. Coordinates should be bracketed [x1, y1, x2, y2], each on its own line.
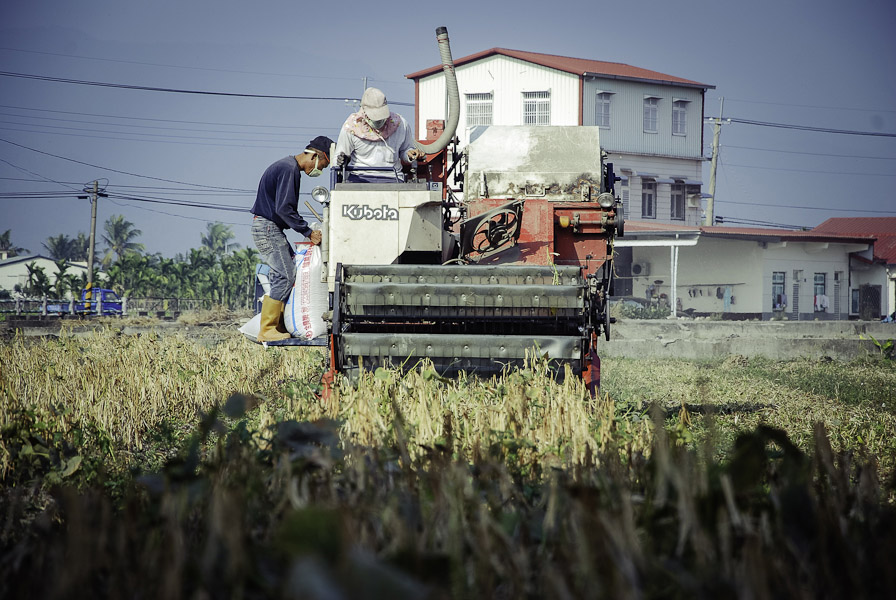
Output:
[407, 48, 714, 226]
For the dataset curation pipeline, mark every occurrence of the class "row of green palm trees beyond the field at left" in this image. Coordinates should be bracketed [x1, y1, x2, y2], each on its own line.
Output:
[0, 215, 259, 309]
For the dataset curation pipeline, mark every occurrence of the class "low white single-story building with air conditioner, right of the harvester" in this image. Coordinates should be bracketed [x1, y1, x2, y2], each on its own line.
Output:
[614, 221, 880, 321]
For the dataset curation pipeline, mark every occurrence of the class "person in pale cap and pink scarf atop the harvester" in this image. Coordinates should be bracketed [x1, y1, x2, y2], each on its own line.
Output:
[336, 88, 423, 183]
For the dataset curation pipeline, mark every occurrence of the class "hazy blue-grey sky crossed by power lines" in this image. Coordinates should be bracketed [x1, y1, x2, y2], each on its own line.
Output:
[0, 0, 896, 257]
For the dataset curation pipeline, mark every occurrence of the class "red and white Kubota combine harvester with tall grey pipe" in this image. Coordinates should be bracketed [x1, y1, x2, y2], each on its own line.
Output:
[270, 28, 624, 394]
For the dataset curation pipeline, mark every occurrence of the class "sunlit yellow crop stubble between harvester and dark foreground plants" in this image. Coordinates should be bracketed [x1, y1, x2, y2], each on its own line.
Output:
[0, 327, 896, 482]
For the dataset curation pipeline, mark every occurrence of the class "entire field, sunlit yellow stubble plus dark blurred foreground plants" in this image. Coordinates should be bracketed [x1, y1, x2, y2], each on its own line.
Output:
[0, 328, 896, 598]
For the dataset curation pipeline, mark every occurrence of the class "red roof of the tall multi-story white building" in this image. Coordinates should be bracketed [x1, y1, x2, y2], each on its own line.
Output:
[405, 48, 715, 89]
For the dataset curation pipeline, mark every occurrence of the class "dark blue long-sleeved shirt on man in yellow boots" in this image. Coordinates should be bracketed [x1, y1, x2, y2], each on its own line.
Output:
[252, 156, 311, 237]
